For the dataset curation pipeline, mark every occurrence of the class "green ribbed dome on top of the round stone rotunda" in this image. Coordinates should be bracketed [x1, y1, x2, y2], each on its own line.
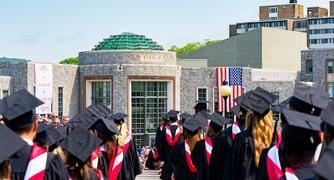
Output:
[93, 33, 163, 51]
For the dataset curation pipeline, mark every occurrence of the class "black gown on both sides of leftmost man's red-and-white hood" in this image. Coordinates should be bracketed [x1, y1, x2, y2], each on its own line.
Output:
[10, 144, 69, 180]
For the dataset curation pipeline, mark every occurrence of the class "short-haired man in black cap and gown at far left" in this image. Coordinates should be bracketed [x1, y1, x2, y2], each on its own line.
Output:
[0, 90, 69, 180]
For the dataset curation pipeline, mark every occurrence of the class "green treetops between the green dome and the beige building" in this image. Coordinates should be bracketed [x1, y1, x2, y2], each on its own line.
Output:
[168, 39, 220, 55]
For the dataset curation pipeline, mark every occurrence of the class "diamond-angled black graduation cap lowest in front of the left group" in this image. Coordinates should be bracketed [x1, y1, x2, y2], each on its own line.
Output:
[61, 127, 102, 162]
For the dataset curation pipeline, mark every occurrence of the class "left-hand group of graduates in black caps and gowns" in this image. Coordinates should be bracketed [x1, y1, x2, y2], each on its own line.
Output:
[0, 90, 142, 180]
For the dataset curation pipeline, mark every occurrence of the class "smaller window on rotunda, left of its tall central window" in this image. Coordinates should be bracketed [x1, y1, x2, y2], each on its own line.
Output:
[91, 81, 111, 108]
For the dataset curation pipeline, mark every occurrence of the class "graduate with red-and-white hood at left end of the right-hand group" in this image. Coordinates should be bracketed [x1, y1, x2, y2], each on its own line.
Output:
[159, 110, 182, 179]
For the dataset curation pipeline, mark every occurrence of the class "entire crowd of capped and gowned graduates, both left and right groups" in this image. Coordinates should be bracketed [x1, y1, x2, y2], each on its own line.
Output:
[0, 81, 334, 180]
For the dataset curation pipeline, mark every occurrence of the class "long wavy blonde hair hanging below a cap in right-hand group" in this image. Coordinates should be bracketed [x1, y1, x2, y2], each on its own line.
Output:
[246, 111, 274, 167]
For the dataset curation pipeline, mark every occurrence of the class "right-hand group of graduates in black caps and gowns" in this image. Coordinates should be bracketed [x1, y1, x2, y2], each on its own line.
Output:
[146, 81, 334, 180]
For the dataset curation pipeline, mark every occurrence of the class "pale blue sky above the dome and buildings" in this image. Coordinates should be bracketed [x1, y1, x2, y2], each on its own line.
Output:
[0, 0, 329, 62]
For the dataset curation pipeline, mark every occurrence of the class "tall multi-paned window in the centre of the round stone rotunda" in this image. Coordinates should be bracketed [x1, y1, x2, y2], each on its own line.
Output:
[131, 81, 168, 146]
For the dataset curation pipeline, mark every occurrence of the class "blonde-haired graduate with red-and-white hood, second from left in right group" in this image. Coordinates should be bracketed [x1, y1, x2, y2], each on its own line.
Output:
[170, 117, 203, 180]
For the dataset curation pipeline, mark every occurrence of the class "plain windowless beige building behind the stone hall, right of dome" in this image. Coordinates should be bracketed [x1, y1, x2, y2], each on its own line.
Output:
[178, 28, 308, 71]
